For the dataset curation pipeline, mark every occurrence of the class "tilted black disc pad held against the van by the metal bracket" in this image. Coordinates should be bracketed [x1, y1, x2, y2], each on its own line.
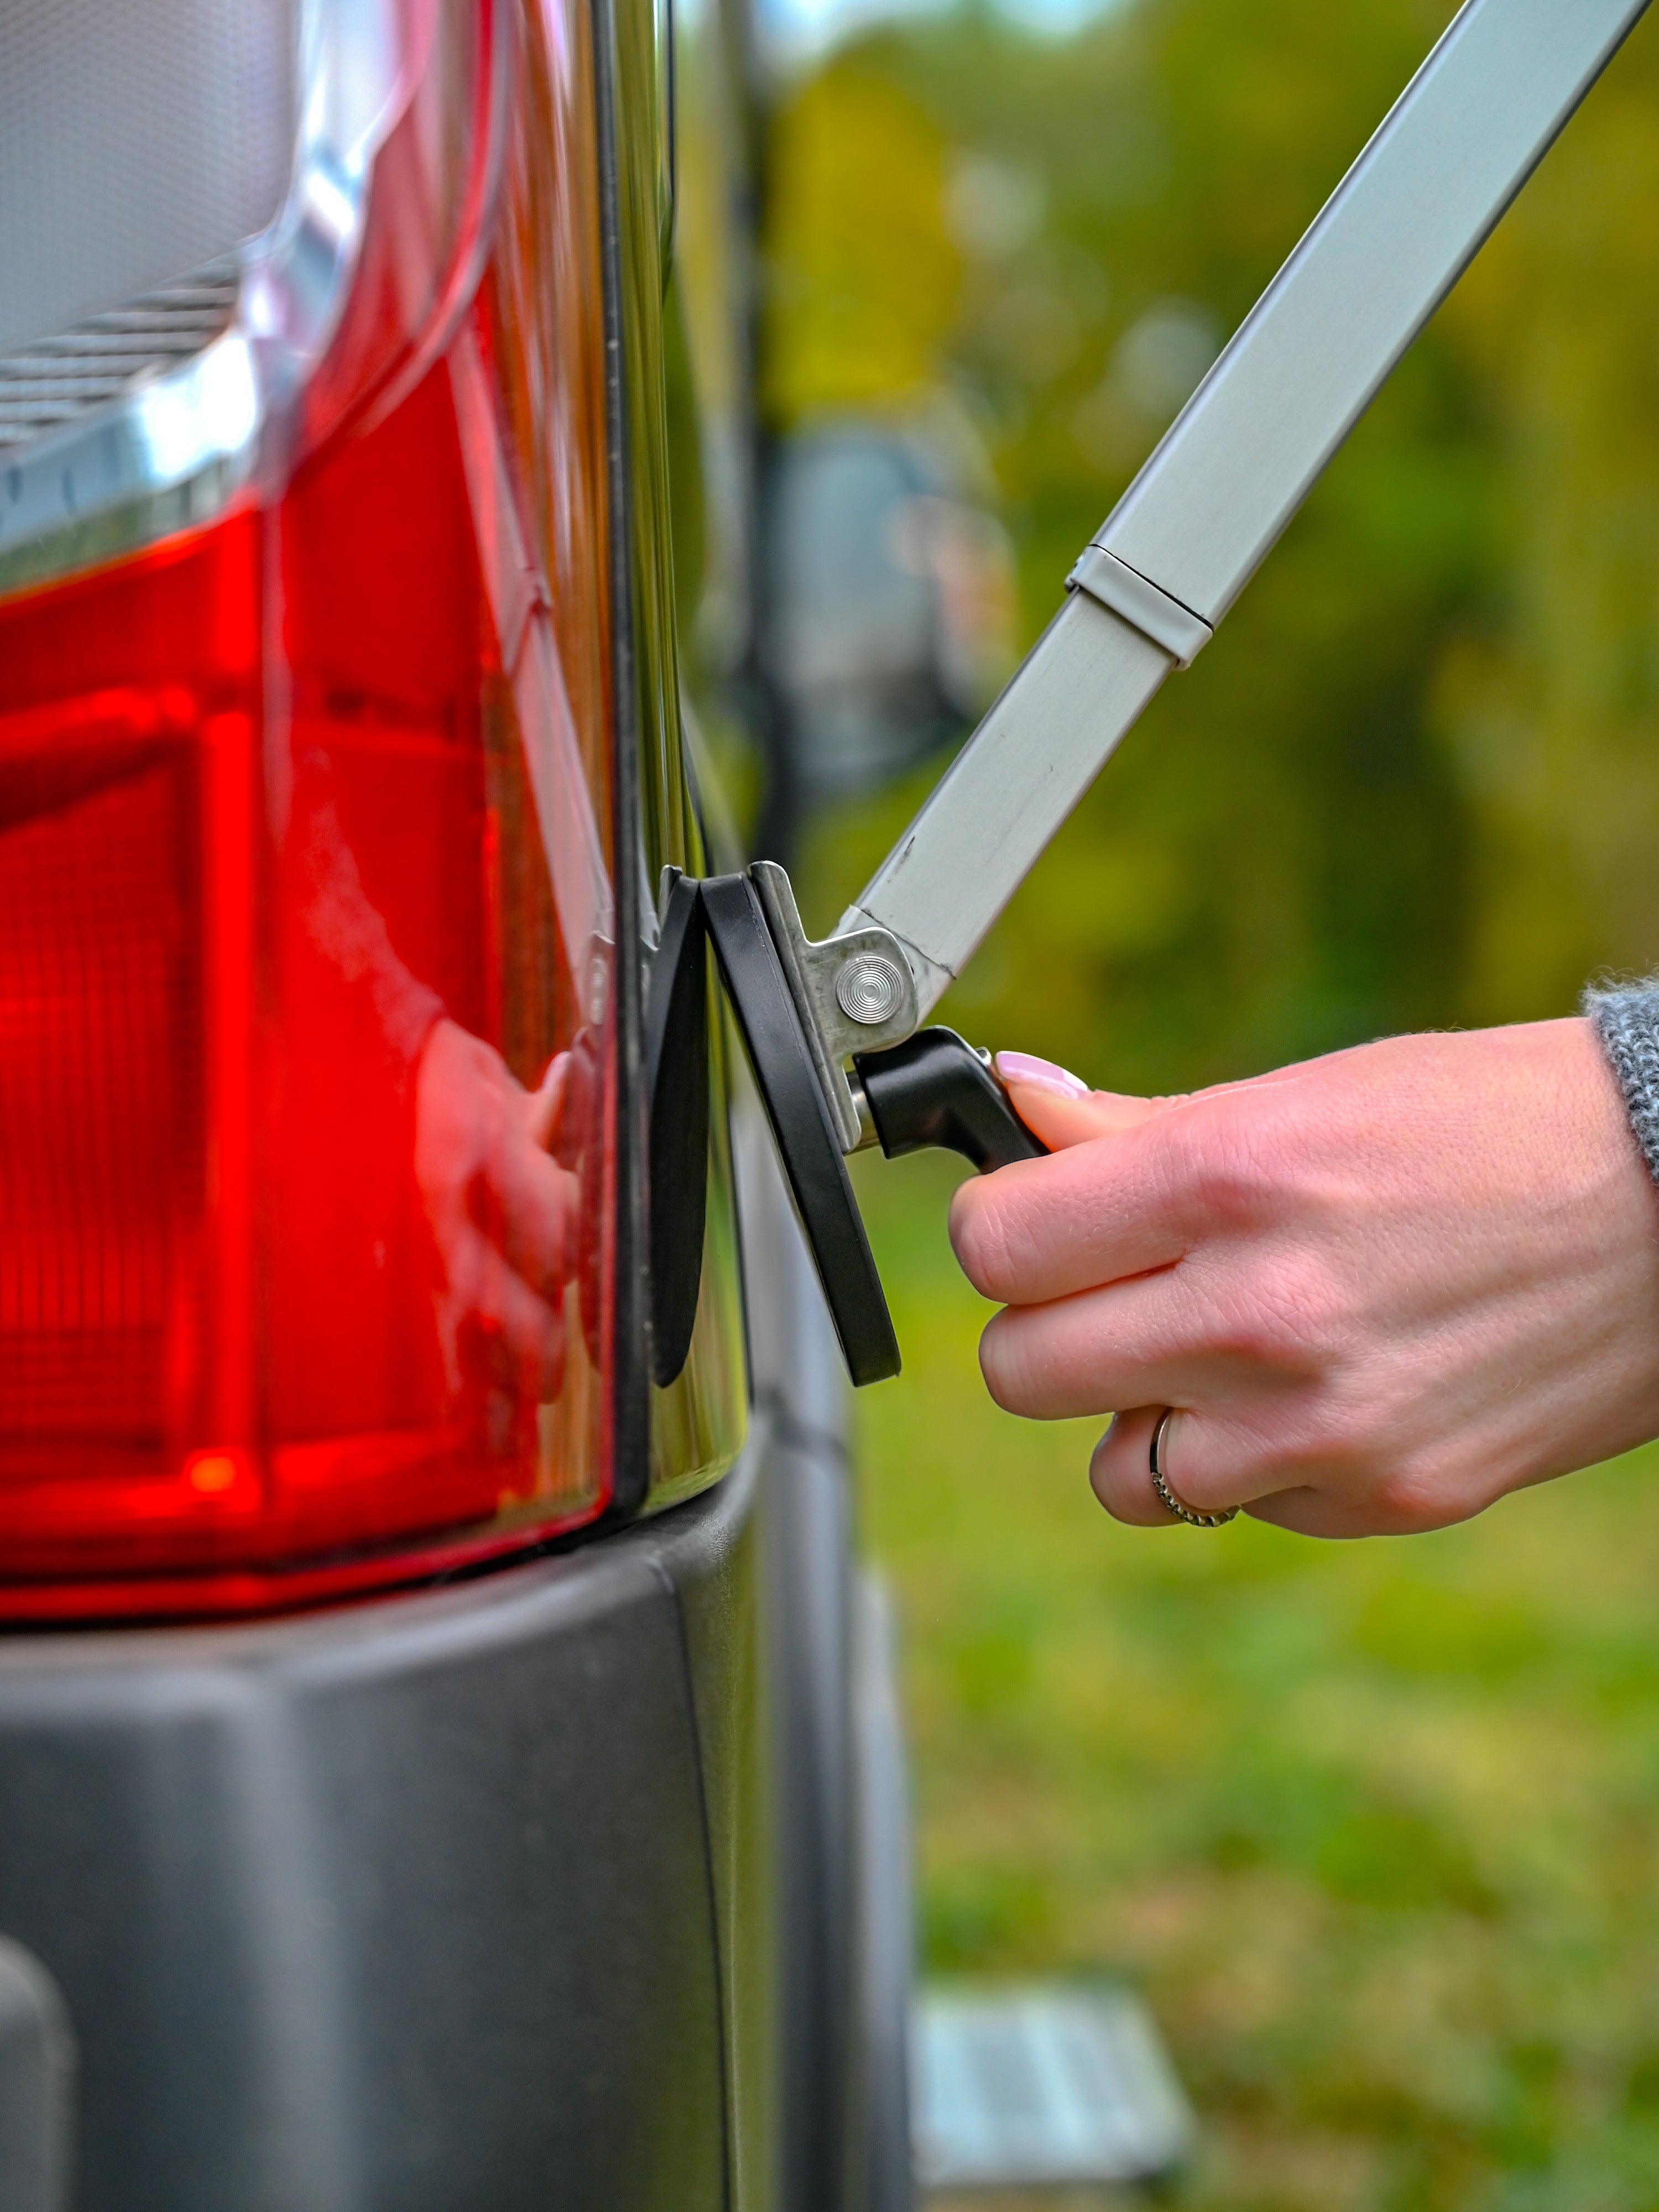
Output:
[703, 876, 900, 1387]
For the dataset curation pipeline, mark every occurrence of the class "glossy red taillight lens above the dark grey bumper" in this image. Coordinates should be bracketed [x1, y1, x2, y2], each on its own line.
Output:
[0, 4, 617, 1617]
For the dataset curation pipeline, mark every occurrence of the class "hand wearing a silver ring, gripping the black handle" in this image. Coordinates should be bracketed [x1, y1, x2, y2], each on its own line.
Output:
[951, 1020, 1659, 1535]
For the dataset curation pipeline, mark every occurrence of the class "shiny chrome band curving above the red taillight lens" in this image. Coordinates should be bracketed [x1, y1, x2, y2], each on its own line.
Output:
[0, 0, 409, 593]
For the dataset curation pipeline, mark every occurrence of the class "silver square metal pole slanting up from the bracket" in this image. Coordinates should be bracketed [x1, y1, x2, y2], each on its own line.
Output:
[841, 0, 1648, 1018]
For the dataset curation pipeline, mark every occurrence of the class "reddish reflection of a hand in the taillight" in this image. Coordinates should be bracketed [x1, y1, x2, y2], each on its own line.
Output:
[414, 1020, 580, 1405]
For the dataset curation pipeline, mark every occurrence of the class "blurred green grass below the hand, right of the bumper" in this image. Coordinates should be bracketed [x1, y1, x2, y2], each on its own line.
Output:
[858, 1159, 1659, 2212]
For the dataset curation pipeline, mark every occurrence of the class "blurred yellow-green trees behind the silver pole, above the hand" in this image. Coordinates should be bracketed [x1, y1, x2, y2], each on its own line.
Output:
[765, 0, 1659, 1088]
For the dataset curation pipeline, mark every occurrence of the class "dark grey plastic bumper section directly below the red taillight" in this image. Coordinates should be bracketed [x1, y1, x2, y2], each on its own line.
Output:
[0, 1478, 734, 2212]
